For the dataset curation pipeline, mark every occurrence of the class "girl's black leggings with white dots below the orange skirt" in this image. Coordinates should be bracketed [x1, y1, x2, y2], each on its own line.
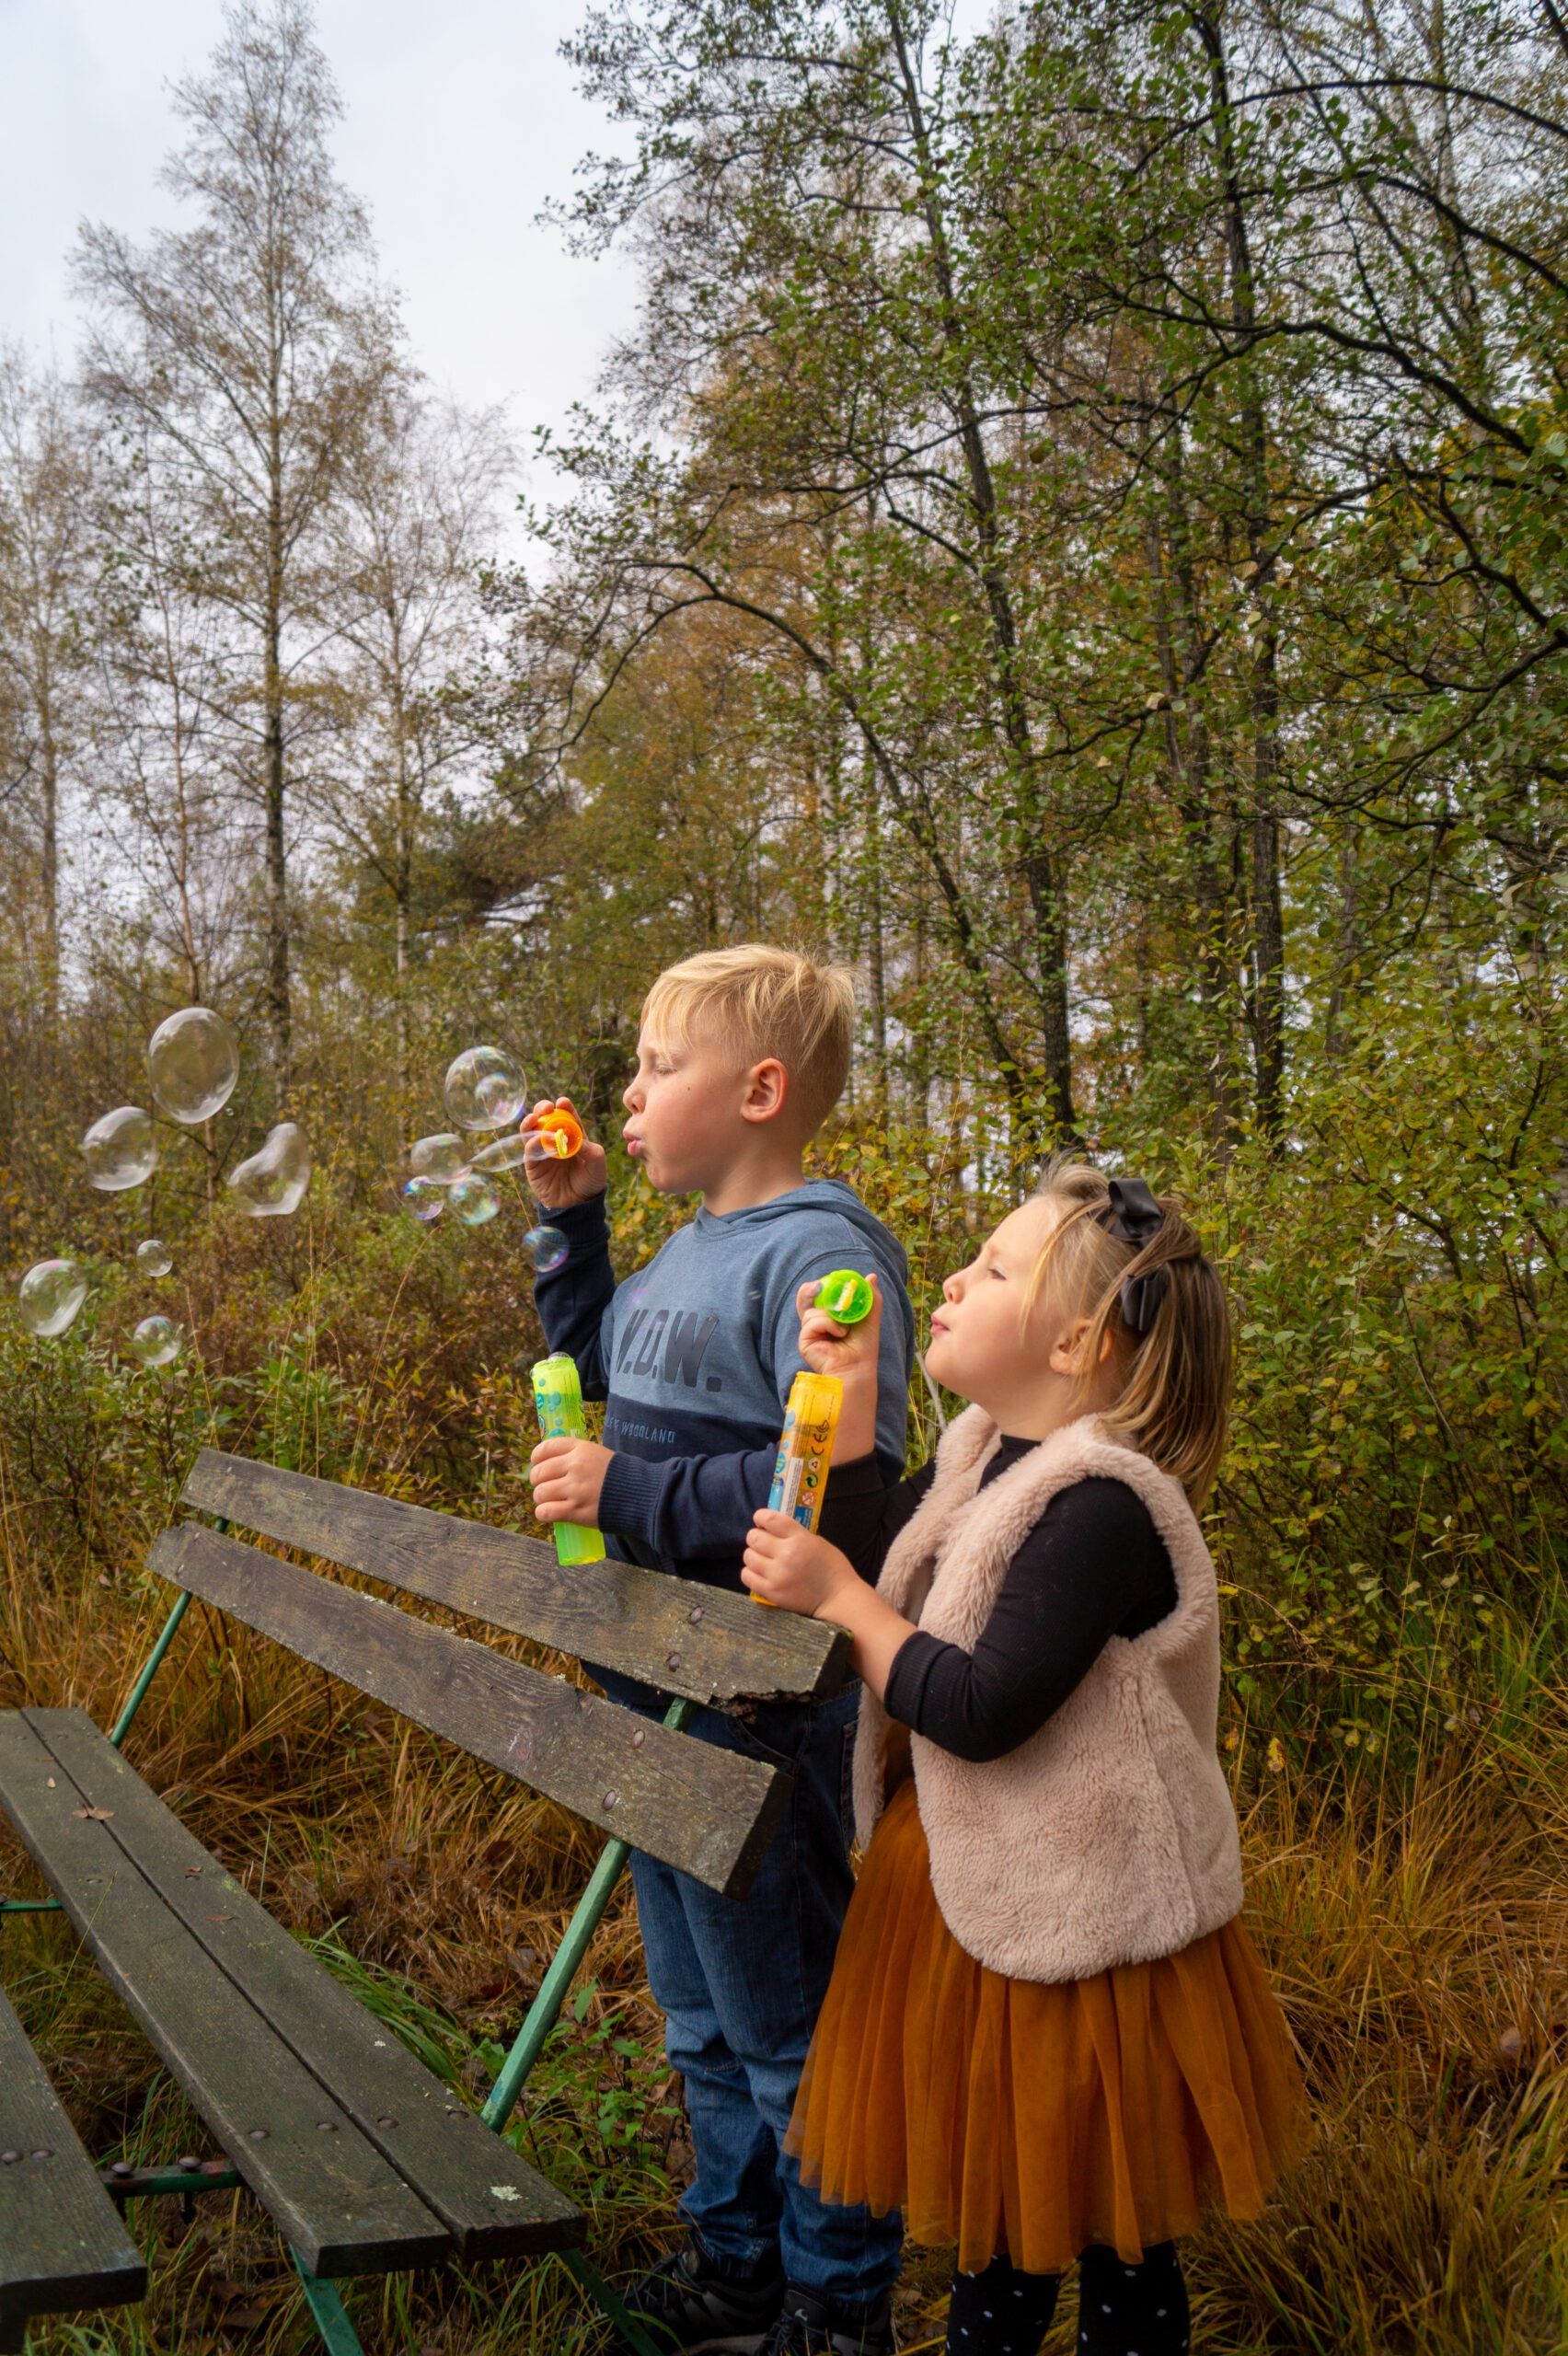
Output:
[947, 2241, 1189, 2356]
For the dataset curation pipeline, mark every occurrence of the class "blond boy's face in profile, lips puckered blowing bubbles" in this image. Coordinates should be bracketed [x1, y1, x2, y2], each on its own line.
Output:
[621, 1032, 787, 1195]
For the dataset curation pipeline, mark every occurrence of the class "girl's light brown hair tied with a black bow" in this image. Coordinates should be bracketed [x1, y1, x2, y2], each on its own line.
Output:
[1029, 1160, 1231, 1506]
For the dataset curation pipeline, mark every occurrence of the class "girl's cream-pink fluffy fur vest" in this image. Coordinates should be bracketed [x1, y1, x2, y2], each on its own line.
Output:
[855, 1406, 1240, 1981]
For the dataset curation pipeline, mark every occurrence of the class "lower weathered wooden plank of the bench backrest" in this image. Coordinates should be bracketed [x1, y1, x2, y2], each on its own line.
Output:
[148, 1522, 789, 1897]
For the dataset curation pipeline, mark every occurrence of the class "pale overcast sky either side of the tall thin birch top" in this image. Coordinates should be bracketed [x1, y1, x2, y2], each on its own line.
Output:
[0, 0, 636, 490]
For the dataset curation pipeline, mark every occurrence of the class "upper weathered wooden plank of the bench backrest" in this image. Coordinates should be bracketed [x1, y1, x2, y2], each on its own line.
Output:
[184, 1449, 850, 1701]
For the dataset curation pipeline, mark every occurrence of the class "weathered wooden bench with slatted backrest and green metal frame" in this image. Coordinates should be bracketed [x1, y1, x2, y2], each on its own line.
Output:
[0, 1449, 847, 2351]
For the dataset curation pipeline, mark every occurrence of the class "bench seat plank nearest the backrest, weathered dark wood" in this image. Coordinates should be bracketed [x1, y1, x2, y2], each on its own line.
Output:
[26, 1711, 582, 2257]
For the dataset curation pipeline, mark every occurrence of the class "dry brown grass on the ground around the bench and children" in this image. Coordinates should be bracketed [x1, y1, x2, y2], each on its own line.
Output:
[0, 1450, 1568, 2356]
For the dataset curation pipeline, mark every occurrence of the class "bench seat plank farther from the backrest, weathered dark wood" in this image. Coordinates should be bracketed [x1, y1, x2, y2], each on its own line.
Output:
[0, 1711, 452, 2276]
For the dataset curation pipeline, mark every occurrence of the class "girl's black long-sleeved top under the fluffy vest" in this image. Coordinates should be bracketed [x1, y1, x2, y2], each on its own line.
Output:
[822, 1438, 1177, 1760]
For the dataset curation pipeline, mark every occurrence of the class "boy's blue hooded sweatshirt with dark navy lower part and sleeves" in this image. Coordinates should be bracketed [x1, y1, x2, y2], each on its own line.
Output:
[535, 1178, 914, 1588]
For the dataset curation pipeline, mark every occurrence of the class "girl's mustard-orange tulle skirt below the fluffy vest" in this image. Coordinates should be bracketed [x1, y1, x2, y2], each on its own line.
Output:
[787, 1781, 1309, 2273]
